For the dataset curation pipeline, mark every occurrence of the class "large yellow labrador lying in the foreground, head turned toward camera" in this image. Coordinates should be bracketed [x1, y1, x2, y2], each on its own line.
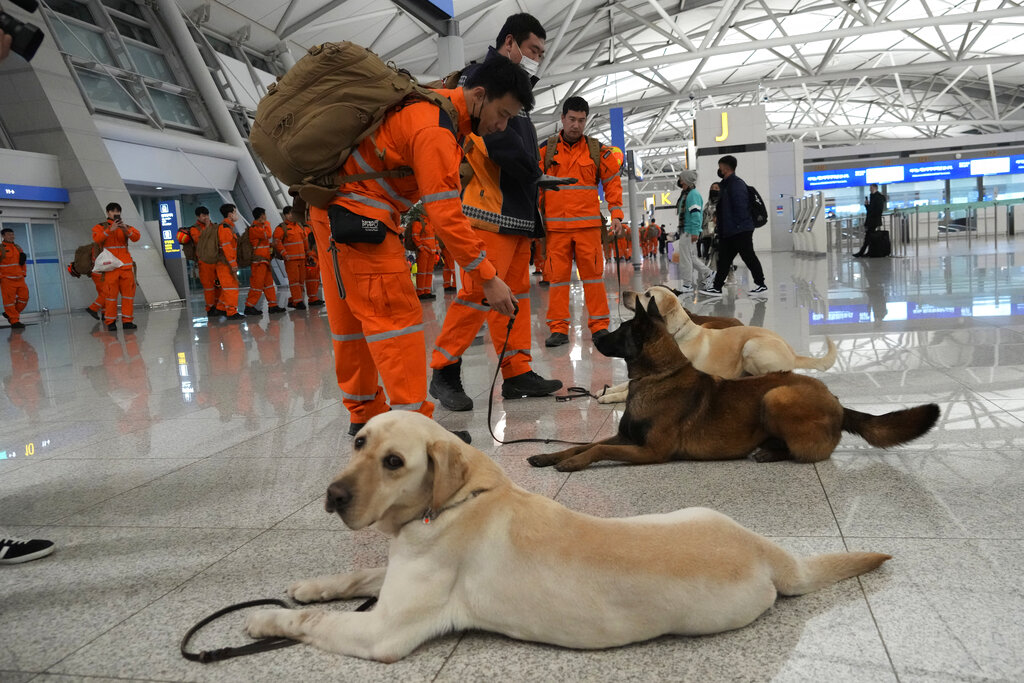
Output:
[246, 411, 890, 661]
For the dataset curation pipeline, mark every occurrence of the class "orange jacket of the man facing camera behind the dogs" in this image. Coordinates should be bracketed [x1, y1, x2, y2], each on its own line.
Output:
[541, 135, 625, 232]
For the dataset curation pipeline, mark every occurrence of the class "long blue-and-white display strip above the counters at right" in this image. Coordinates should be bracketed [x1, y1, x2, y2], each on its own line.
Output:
[804, 155, 1024, 189]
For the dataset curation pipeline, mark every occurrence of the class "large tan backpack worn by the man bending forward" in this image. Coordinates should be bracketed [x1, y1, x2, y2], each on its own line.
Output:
[249, 41, 459, 208]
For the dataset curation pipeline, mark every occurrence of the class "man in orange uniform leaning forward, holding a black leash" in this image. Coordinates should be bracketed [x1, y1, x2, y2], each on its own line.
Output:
[310, 56, 534, 434]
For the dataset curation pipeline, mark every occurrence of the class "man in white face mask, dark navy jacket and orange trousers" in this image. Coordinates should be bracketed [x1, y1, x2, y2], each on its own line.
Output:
[430, 13, 562, 411]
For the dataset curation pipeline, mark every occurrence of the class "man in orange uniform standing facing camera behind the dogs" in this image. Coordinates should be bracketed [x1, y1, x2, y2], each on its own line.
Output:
[541, 97, 623, 346]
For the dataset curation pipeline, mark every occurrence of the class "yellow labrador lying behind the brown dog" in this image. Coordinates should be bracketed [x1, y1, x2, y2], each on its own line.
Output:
[597, 286, 838, 403]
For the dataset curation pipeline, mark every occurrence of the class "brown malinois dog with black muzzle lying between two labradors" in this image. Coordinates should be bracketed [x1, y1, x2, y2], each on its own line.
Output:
[529, 300, 939, 472]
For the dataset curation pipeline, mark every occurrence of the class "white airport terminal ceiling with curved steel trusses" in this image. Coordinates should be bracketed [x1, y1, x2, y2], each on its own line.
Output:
[180, 0, 1024, 184]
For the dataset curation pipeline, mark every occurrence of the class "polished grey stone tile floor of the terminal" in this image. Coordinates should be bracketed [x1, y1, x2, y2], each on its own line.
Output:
[0, 240, 1024, 683]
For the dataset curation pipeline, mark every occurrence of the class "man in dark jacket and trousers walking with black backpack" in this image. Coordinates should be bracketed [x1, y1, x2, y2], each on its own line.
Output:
[700, 155, 768, 296]
